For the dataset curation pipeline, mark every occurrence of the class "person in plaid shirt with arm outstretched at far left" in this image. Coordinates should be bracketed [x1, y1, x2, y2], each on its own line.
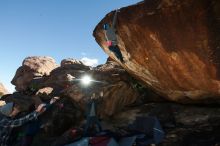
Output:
[0, 102, 46, 146]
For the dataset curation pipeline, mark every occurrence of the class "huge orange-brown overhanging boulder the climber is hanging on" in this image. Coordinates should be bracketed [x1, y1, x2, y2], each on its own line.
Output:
[93, 0, 220, 103]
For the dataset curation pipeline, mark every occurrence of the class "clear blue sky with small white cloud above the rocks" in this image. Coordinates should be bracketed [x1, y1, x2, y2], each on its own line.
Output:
[0, 0, 141, 91]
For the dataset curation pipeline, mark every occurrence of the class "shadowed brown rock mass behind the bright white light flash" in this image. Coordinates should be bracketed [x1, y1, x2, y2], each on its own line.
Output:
[43, 58, 139, 117]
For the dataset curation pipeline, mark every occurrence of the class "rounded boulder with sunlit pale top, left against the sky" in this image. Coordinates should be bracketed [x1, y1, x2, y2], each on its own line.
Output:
[11, 56, 58, 91]
